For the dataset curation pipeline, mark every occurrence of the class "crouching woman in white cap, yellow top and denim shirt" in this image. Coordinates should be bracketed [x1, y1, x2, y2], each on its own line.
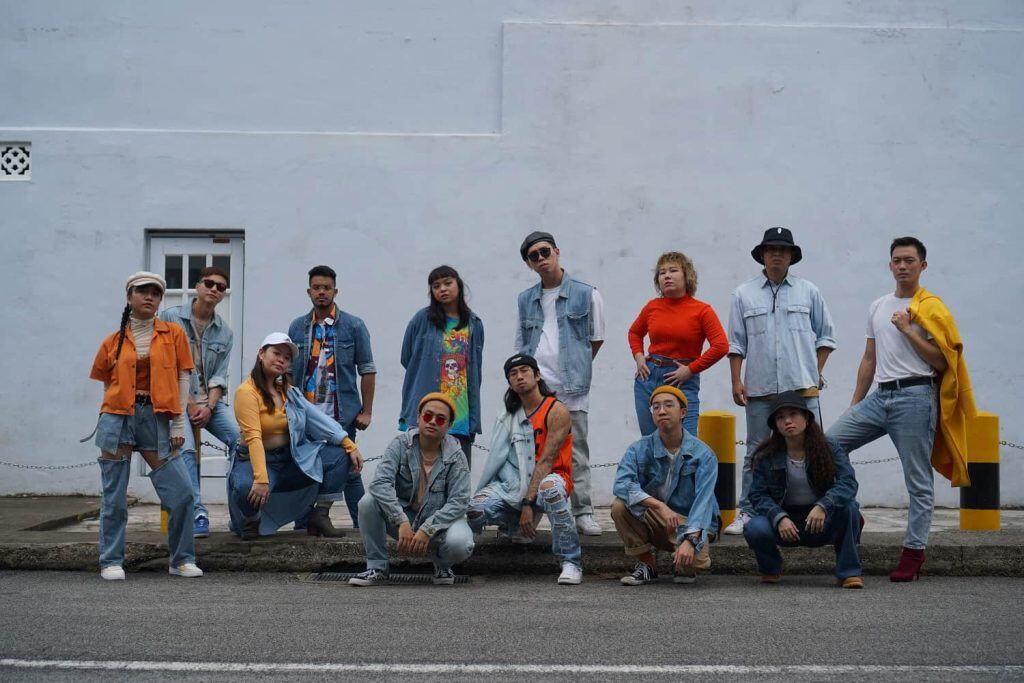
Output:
[227, 332, 362, 541]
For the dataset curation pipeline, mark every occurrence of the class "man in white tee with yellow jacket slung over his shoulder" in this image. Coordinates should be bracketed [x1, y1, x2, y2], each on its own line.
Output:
[828, 237, 975, 582]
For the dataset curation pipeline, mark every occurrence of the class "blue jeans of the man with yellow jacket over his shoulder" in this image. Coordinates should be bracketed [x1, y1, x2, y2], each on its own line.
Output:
[828, 384, 939, 550]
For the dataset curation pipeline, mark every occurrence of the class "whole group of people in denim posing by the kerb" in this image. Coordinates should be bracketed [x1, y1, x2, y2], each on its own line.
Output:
[91, 227, 974, 588]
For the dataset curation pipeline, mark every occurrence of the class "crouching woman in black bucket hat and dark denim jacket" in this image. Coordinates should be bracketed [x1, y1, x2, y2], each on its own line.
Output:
[743, 391, 864, 588]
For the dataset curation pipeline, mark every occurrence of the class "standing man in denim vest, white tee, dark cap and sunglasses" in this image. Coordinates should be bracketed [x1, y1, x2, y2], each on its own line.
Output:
[515, 231, 604, 536]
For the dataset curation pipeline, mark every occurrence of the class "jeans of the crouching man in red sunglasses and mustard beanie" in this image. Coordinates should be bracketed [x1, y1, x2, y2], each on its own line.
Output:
[359, 496, 475, 571]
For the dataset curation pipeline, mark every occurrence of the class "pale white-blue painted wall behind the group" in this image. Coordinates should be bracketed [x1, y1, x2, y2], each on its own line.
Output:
[0, 0, 1024, 505]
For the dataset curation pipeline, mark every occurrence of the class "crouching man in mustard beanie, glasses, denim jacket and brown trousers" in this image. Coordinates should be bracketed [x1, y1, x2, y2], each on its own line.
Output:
[611, 385, 721, 586]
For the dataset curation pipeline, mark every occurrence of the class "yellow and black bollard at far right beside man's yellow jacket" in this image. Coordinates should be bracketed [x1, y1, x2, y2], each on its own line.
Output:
[961, 412, 1001, 531]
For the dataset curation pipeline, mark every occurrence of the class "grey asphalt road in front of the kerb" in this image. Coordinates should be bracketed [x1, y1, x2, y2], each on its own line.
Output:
[0, 571, 1024, 681]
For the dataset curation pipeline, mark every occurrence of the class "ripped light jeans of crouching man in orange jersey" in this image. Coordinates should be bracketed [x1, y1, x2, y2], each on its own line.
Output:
[467, 474, 583, 566]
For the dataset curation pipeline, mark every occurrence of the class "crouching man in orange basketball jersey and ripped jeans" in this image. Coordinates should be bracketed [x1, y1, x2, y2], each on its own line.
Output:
[469, 354, 583, 585]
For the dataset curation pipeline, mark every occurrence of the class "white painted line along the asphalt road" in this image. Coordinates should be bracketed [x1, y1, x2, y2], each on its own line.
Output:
[0, 658, 1024, 676]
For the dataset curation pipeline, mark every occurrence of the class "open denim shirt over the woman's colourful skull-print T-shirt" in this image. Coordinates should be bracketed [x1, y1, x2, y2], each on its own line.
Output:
[398, 308, 483, 434]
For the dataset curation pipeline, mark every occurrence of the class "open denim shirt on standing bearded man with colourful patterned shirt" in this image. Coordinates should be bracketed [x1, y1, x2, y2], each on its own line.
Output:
[288, 308, 377, 425]
